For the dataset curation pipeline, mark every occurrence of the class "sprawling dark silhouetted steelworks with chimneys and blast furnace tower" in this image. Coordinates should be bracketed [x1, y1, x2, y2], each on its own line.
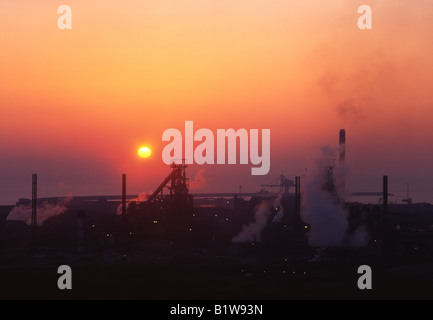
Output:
[0, 129, 433, 298]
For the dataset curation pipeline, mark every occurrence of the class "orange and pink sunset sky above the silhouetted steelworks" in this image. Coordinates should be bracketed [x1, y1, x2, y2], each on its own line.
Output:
[0, 0, 433, 204]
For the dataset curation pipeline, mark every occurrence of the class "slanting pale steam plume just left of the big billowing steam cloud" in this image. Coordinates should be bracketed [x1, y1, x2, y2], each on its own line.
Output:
[232, 200, 271, 243]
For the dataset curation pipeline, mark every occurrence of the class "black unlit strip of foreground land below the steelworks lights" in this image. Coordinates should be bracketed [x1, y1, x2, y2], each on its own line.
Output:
[0, 252, 433, 300]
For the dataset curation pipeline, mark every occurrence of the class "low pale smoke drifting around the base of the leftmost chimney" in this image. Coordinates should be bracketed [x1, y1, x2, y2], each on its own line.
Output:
[7, 196, 72, 226]
